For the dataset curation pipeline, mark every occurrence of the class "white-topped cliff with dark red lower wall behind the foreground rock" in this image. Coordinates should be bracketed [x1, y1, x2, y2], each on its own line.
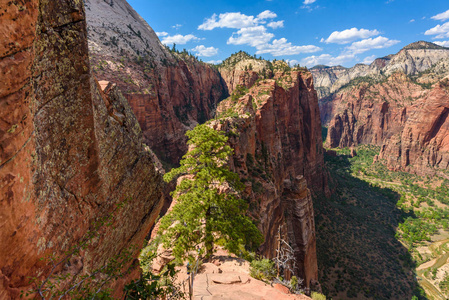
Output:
[85, 0, 226, 165]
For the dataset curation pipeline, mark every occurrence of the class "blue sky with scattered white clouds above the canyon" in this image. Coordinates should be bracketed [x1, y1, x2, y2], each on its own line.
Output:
[128, 0, 449, 67]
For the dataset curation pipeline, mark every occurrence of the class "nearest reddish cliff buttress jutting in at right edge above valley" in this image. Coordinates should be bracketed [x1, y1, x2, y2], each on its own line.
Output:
[379, 79, 449, 175]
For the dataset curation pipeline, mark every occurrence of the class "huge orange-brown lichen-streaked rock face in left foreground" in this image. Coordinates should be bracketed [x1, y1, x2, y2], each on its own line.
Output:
[0, 0, 162, 299]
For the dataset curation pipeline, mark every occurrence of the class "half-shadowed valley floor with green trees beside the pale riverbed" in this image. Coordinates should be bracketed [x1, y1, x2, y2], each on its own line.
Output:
[315, 146, 449, 299]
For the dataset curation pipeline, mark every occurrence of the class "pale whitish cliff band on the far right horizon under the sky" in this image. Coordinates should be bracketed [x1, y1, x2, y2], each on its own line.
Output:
[311, 41, 449, 99]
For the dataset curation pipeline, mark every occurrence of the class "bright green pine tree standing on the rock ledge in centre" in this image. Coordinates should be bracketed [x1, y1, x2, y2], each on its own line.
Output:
[159, 124, 263, 260]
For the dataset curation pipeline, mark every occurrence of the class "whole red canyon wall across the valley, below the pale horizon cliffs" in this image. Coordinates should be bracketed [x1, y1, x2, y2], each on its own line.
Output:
[321, 54, 449, 174]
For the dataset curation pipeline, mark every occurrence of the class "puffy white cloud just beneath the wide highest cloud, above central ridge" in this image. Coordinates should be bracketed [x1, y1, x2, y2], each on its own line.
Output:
[227, 25, 274, 48]
